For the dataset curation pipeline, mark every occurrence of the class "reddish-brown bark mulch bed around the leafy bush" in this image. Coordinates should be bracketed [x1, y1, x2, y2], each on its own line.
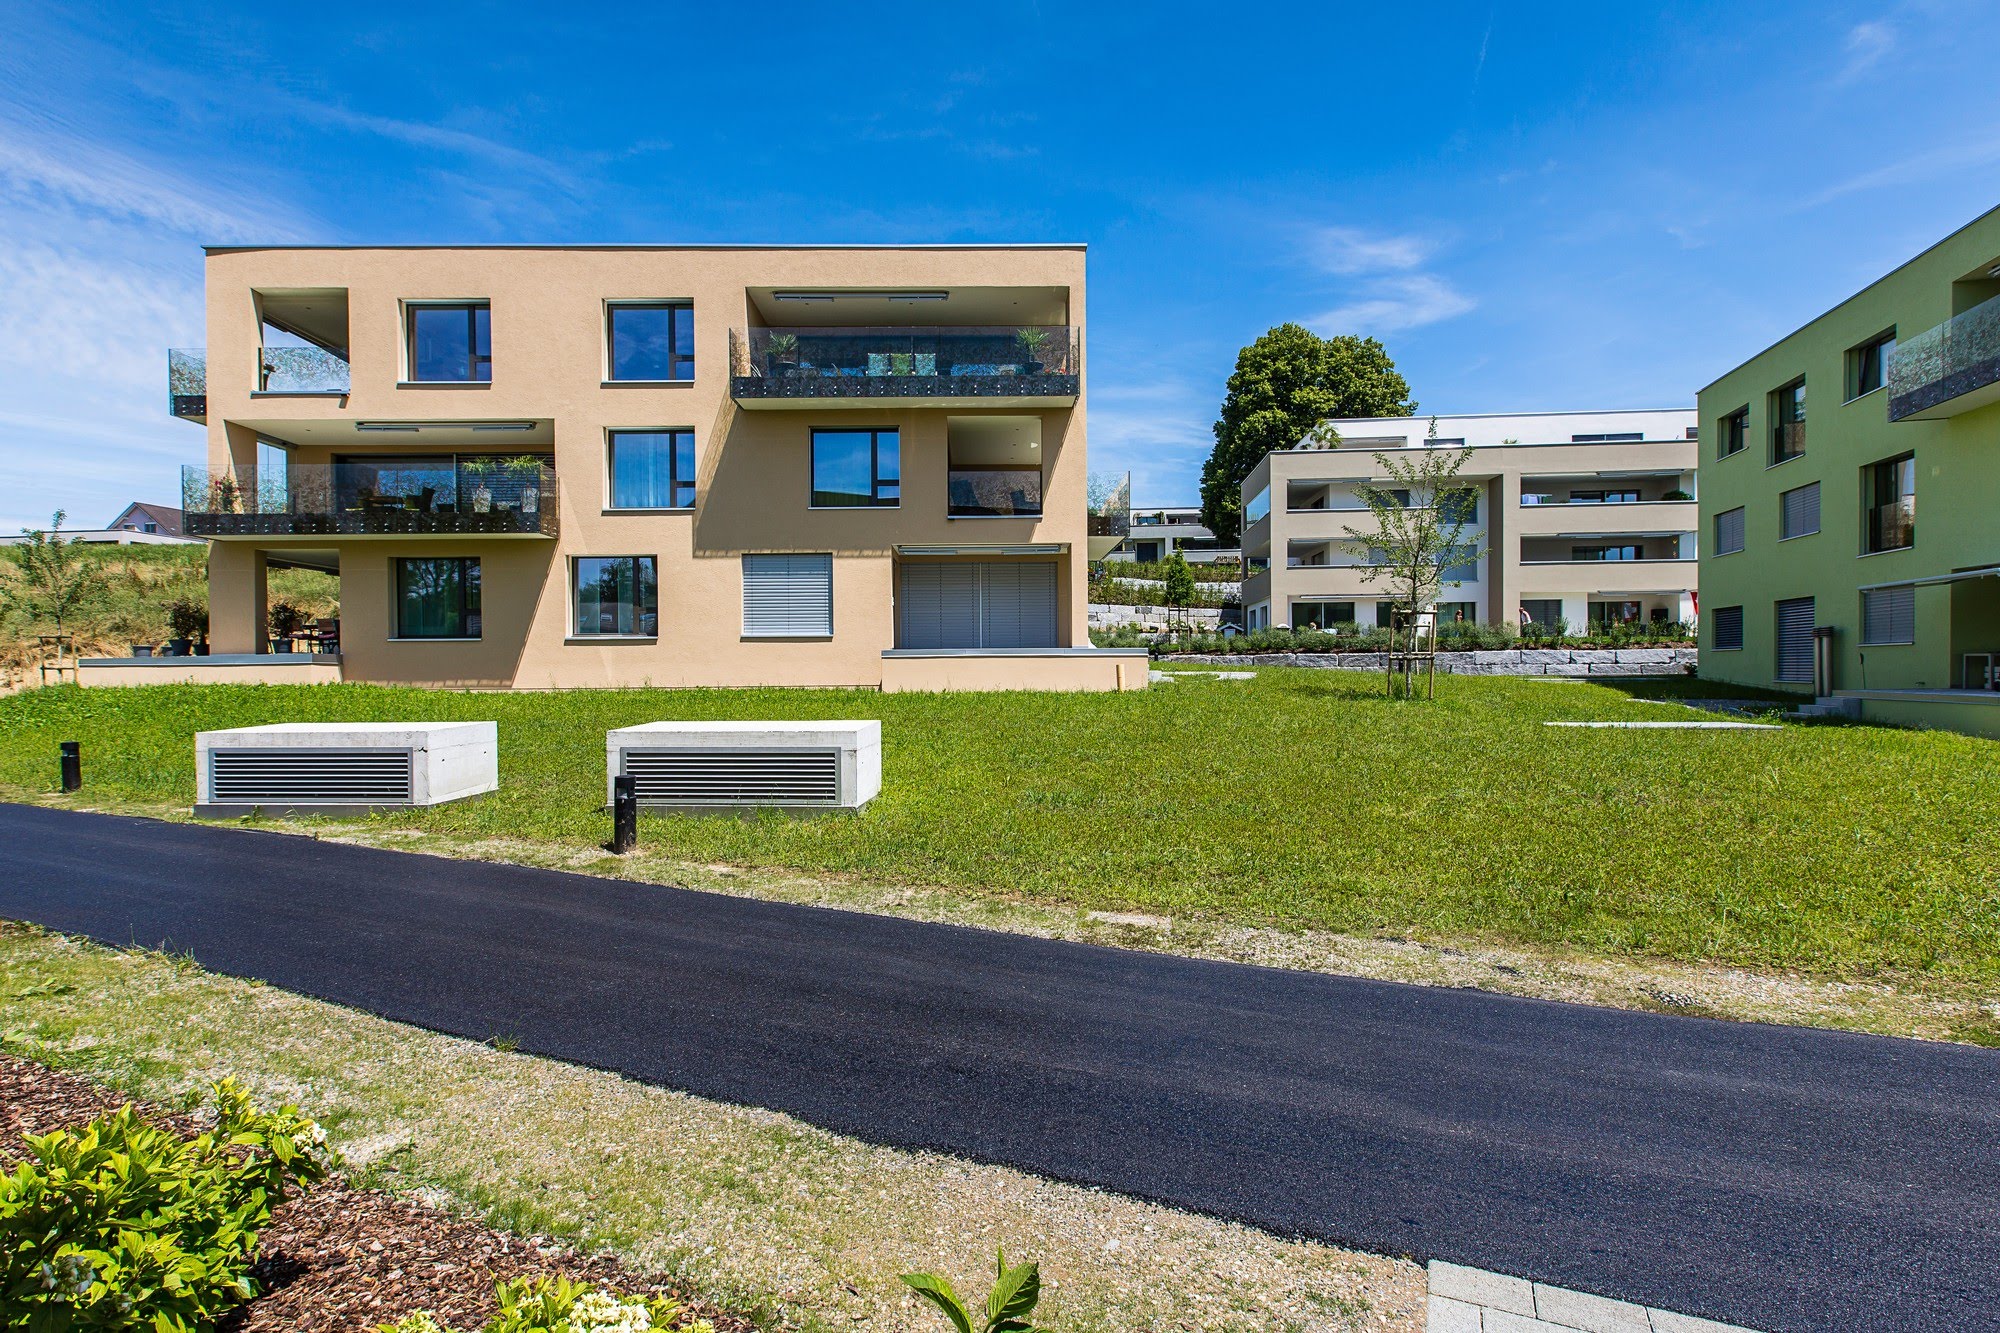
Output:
[0, 1055, 756, 1333]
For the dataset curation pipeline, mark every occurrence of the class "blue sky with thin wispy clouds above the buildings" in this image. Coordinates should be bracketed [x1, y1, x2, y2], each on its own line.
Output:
[0, 0, 2000, 530]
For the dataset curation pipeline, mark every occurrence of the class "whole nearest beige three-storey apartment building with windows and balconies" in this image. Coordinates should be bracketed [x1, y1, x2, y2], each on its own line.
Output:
[156, 246, 1146, 691]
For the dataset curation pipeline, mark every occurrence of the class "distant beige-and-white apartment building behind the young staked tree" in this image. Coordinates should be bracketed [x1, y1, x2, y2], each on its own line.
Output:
[1242, 408, 1698, 628]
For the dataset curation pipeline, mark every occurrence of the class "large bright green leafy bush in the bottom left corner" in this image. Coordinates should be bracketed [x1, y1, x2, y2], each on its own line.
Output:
[0, 1079, 334, 1333]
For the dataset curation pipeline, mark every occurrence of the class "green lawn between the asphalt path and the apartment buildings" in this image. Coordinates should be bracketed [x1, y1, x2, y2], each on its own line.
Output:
[0, 669, 2000, 981]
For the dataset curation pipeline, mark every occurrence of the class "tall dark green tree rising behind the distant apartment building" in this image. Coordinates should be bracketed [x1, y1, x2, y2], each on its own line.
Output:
[1202, 324, 1416, 546]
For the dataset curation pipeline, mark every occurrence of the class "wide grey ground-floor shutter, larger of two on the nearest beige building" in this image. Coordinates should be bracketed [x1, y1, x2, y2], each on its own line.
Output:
[898, 560, 1056, 648]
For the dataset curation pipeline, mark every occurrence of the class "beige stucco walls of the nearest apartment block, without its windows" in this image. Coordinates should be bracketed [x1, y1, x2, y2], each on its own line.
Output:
[168, 246, 1144, 689]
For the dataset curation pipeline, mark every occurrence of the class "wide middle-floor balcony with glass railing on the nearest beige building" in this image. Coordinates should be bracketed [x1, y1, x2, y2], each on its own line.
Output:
[180, 454, 558, 538]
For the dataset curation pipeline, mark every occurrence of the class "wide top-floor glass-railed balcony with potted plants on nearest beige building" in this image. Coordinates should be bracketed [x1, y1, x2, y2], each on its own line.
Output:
[730, 326, 1080, 408]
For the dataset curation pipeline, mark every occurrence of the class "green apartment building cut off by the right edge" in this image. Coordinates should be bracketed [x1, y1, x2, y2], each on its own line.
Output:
[1698, 208, 2000, 737]
